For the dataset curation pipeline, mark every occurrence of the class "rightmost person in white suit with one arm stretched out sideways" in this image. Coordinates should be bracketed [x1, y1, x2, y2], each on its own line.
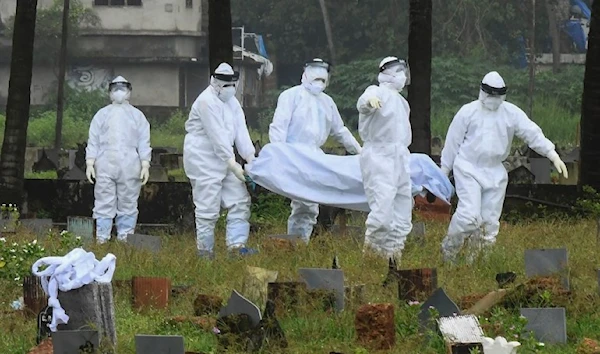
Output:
[441, 71, 568, 262]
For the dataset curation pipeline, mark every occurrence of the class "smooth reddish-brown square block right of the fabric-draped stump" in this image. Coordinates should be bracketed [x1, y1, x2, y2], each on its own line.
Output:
[131, 277, 171, 310]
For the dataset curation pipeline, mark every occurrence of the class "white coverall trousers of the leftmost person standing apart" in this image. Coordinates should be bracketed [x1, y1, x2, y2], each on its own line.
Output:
[93, 147, 142, 243]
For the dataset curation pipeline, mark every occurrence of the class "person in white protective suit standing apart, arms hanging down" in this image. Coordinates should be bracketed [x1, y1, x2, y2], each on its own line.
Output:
[85, 76, 152, 243]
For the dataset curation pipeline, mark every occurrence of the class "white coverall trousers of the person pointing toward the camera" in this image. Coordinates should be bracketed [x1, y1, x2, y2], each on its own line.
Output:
[360, 142, 413, 257]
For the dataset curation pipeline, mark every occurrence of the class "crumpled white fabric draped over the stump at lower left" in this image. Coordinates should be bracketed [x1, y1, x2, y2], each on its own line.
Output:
[31, 248, 117, 332]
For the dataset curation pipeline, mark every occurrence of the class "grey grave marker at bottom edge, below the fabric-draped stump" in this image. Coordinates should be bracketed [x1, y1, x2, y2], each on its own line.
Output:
[52, 330, 100, 354]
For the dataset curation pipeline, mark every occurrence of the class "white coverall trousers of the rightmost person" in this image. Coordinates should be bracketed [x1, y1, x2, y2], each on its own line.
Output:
[442, 156, 508, 261]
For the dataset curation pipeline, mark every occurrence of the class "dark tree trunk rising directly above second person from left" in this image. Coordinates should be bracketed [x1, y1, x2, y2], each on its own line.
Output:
[208, 0, 233, 74]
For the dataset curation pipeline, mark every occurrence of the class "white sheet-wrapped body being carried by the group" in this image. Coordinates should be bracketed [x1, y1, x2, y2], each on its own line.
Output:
[246, 143, 454, 212]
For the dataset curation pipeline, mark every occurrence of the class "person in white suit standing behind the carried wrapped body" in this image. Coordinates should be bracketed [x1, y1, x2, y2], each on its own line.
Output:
[269, 58, 361, 243]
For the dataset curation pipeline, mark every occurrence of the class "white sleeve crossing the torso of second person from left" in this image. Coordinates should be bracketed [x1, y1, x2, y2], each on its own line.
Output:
[196, 101, 234, 161]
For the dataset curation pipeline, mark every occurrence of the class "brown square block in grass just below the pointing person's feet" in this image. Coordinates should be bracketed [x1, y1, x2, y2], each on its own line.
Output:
[396, 268, 437, 302]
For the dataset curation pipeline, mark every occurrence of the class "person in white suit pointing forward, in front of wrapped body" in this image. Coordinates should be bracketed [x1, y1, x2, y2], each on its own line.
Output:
[356, 57, 413, 260]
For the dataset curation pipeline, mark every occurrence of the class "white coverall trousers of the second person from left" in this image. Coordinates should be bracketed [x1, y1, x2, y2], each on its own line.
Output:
[183, 134, 251, 252]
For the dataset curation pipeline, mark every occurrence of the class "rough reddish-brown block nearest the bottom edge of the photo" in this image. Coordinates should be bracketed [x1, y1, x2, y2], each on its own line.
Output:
[354, 304, 396, 350]
